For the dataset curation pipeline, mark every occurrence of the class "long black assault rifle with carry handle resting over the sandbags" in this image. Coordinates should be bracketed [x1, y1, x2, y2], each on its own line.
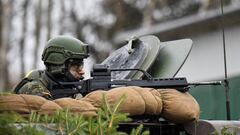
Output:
[51, 65, 221, 99]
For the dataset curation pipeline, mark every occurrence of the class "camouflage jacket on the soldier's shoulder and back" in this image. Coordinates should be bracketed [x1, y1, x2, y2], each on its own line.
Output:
[14, 70, 52, 99]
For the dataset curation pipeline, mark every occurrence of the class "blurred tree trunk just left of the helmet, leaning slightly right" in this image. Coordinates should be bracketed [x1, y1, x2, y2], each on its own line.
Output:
[33, 0, 42, 69]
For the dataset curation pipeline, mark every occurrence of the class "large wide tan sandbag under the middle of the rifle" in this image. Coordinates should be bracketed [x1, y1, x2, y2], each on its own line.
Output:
[82, 87, 145, 115]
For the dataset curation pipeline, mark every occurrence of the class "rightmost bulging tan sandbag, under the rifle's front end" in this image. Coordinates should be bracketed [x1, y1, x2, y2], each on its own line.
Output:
[158, 89, 200, 123]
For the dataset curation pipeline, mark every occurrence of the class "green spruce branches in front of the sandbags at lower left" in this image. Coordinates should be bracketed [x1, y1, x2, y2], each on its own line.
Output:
[0, 96, 149, 135]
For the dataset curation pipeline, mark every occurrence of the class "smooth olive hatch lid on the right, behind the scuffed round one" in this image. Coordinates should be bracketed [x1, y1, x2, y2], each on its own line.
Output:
[148, 39, 192, 78]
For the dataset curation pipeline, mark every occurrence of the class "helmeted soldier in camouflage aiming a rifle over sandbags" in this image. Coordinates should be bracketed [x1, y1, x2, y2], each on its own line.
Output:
[14, 36, 88, 99]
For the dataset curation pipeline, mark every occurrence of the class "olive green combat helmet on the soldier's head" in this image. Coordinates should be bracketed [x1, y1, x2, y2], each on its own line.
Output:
[42, 36, 89, 65]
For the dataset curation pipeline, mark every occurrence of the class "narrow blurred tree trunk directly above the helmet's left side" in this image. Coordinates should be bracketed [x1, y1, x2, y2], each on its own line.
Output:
[47, 0, 53, 40]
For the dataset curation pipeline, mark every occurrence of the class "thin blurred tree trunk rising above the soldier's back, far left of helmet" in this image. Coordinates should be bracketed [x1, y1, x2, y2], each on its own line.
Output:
[20, 0, 29, 78]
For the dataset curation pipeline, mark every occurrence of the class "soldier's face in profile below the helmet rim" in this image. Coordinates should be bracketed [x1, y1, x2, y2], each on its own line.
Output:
[69, 65, 85, 80]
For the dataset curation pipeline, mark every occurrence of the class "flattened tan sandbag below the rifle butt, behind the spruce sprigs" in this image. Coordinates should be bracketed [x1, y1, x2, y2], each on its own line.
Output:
[54, 98, 97, 116]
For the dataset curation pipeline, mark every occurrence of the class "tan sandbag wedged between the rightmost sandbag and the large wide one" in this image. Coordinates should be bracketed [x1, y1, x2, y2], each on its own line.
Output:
[130, 86, 162, 115]
